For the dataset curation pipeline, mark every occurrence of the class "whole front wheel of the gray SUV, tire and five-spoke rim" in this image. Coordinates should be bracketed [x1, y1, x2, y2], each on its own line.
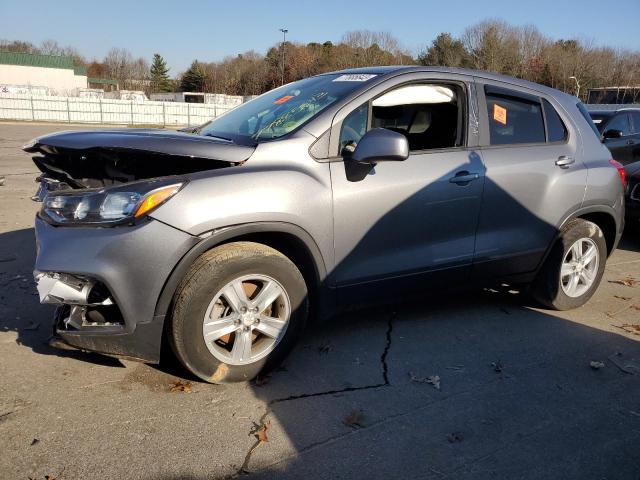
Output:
[170, 242, 308, 383]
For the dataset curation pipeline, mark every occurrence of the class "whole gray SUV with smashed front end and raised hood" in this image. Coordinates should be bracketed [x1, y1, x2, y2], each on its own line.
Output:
[25, 67, 624, 382]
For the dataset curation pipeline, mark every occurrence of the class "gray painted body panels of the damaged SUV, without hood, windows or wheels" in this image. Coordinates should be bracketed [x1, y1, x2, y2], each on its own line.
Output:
[31, 67, 623, 360]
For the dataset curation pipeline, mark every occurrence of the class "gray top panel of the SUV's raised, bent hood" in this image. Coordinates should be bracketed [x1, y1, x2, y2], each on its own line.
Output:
[24, 129, 255, 163]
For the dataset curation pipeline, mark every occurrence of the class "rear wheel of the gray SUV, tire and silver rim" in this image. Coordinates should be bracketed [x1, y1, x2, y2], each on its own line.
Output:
[532, 218, 607, 310]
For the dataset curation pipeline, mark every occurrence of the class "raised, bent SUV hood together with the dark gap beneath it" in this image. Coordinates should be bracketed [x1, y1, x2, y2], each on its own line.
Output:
[24, 129, 255, 189]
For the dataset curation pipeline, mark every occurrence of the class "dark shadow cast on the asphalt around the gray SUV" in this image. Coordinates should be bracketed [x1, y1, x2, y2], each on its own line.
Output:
[5, 229, 640, 480]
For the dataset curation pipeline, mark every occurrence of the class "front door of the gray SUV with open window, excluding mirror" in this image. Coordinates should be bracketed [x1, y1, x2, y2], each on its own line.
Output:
[331, 78, 484, 302]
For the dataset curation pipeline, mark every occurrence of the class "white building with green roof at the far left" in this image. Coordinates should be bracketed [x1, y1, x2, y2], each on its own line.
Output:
[0, 52, 87, 95]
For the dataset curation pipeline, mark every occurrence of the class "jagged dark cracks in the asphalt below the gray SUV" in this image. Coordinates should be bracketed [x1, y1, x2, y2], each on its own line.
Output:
[230, 306, 397, 479]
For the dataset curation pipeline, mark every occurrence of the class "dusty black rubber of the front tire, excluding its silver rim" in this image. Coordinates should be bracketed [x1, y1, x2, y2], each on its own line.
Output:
[172, 242, 308, 383]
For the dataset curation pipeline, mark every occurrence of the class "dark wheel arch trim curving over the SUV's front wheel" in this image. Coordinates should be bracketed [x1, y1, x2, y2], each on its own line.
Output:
[154, 222, 327, 315]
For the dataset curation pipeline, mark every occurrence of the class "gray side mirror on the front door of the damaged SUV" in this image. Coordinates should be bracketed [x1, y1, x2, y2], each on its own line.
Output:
[351, 128, 409, 165]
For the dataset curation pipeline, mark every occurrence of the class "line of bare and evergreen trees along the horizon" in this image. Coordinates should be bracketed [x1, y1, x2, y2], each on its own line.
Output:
[0, 20, 640, 99]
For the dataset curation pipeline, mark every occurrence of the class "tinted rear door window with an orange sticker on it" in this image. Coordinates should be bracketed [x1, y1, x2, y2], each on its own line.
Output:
[486, 92, 545, 145]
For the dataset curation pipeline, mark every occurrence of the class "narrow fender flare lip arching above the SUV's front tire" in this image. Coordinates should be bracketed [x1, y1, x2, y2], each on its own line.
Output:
[154, 222, 327, 315]
